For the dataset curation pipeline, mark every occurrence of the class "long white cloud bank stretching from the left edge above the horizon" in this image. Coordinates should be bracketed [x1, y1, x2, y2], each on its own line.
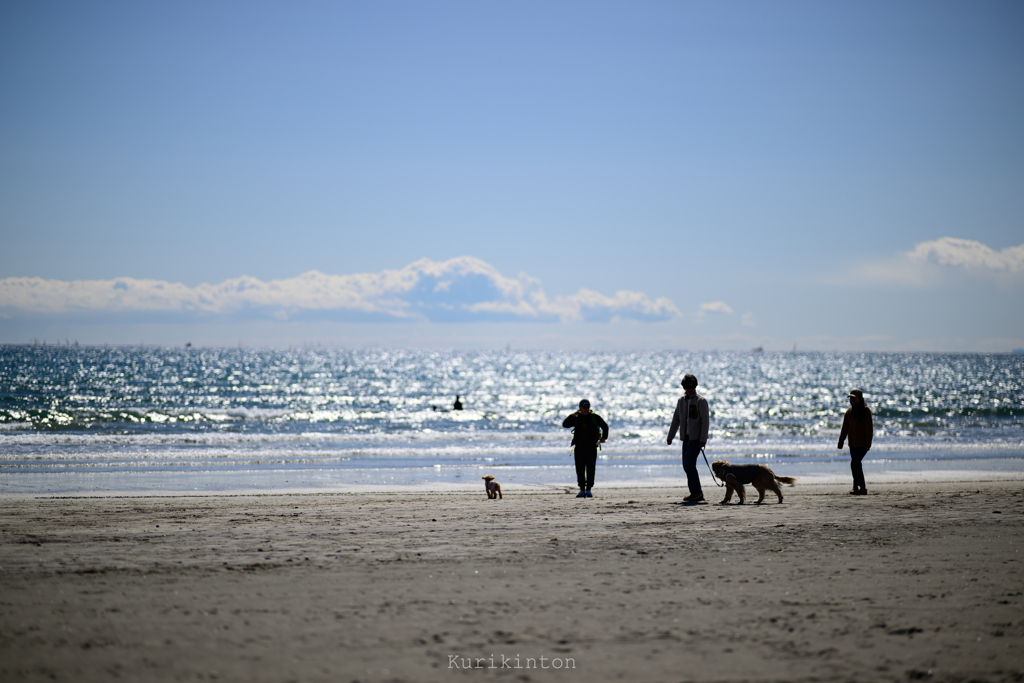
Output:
[0, 256, 679, 322]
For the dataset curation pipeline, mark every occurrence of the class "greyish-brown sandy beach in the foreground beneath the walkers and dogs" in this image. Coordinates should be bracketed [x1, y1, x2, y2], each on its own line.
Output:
[0, 482, 1024, 682]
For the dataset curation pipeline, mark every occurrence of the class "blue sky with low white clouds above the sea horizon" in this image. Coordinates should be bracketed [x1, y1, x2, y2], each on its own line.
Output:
[0, 0, 1024, 352]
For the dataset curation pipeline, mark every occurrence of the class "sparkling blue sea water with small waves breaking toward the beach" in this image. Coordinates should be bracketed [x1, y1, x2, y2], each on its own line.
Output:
[0, 346, 1024, 494]
